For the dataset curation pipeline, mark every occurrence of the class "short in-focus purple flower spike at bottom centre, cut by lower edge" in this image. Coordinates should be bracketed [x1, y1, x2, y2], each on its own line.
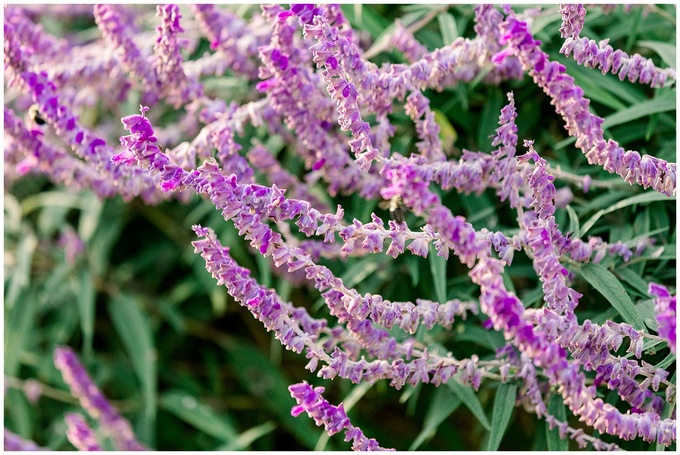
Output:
[288, 381, 394, 452]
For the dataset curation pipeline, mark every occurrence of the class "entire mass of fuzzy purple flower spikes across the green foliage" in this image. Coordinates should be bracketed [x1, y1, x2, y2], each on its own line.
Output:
[4, 4, 677, 451]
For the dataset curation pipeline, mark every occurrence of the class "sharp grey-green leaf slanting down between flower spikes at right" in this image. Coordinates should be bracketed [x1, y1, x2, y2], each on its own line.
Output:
[578, 263, 645, 330]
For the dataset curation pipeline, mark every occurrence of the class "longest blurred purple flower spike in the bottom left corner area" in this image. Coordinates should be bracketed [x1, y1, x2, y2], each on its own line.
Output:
[54, 346, 146, 450]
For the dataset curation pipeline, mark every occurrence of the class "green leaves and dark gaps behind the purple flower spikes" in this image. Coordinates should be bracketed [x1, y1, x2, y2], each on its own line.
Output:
[4, 5, 677, 450]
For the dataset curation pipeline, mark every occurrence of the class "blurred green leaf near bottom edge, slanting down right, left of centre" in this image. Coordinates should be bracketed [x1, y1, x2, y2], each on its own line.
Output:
[159, 390, 238, 443]
